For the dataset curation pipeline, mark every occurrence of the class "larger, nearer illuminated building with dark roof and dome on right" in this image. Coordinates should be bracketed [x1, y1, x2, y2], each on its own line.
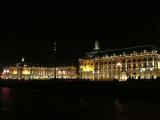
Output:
[79, 41, 160, 80]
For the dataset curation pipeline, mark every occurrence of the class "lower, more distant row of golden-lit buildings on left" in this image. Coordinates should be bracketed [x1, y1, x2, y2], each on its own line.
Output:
[1, 58, 77, 79]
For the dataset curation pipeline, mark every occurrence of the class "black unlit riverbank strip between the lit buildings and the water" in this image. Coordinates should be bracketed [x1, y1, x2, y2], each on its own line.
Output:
[0, 79, 160, 96]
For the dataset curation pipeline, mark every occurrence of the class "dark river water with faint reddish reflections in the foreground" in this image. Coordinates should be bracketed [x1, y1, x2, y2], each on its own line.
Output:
[0, 87, 160, 120]
